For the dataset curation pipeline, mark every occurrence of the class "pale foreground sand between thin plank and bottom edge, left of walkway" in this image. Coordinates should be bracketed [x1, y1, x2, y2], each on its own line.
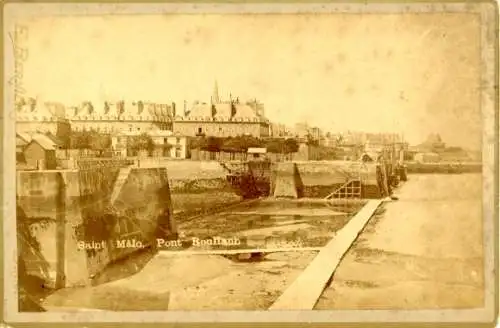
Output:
[43, 252, 316, 311]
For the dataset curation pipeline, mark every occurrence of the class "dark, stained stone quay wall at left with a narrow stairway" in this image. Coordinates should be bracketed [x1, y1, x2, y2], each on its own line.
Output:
[17, 168, 176, 288]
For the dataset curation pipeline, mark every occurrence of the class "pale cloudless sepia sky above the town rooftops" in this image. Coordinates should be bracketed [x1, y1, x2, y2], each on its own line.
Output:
[11, 13, 482, 148]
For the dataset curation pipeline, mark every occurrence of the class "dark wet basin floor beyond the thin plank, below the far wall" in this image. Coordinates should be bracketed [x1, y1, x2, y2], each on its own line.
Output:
[179, 201, 362, 249]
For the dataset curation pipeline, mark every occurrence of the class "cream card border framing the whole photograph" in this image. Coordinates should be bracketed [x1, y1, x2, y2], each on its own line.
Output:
[3, 3, 497, 323]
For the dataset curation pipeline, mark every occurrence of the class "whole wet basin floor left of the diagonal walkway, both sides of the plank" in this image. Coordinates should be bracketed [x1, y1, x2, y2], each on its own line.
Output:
[43, 202, 359, 311]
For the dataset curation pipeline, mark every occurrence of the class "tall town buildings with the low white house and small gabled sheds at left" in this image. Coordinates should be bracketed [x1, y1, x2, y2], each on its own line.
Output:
[16, 82, 280, 166]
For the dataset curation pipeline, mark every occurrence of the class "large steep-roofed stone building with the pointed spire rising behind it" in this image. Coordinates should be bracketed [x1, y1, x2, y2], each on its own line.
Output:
[173, 83, 270, 137]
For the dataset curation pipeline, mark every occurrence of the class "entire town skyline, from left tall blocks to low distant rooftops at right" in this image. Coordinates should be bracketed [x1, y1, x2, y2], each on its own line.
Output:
[16, 82, 410, 167]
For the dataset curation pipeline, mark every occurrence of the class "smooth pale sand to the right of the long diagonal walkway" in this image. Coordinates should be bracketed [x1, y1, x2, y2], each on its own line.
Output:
[315, 174, 484, 310]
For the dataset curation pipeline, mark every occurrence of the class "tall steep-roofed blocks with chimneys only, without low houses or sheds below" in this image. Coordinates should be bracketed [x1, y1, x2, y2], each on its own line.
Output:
[16, 84, 279, 138]
